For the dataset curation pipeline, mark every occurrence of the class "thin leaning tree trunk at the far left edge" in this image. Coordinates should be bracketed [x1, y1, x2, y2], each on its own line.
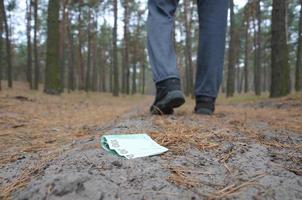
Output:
[0, 0, 13, 88]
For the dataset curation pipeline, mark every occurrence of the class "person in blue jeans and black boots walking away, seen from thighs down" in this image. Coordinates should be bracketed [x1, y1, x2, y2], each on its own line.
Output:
[147, 0, 229, 115]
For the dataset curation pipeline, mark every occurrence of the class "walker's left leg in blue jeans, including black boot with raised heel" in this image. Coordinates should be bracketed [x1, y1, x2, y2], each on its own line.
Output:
[147, 0, 185, 114]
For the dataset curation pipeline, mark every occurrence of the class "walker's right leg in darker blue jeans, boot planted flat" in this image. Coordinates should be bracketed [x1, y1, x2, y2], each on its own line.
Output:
[195, 0, 229, 114]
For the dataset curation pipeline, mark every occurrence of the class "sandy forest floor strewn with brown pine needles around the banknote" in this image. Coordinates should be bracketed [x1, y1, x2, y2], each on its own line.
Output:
[0, 85, 302, 200]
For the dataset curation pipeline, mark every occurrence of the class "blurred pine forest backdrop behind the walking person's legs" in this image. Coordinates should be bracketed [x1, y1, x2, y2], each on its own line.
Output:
[0, 0, 302, 97]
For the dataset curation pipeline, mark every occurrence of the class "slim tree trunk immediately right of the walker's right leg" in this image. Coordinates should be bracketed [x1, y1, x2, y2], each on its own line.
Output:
[227, 0, 236, 97]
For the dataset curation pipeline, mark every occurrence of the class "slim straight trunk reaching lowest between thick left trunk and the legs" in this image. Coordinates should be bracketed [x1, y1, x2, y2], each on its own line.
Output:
[112, 0, 119, 96]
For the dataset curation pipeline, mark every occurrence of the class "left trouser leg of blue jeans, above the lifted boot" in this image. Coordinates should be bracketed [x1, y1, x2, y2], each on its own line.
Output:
[147, 0, 179, 83]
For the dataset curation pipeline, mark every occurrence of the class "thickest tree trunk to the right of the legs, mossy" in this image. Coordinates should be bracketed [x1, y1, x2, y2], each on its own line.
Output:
[270, 0, 290, 97]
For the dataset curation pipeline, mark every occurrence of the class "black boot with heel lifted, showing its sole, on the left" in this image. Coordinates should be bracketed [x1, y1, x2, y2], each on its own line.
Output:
[150, 78, 185, 115]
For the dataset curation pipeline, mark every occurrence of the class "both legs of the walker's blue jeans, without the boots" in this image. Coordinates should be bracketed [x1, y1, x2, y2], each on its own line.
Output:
[147, 0, 229, 97]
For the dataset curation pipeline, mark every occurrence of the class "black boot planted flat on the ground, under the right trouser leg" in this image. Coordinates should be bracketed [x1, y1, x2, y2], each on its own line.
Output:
[194, 96, 216, 115]
